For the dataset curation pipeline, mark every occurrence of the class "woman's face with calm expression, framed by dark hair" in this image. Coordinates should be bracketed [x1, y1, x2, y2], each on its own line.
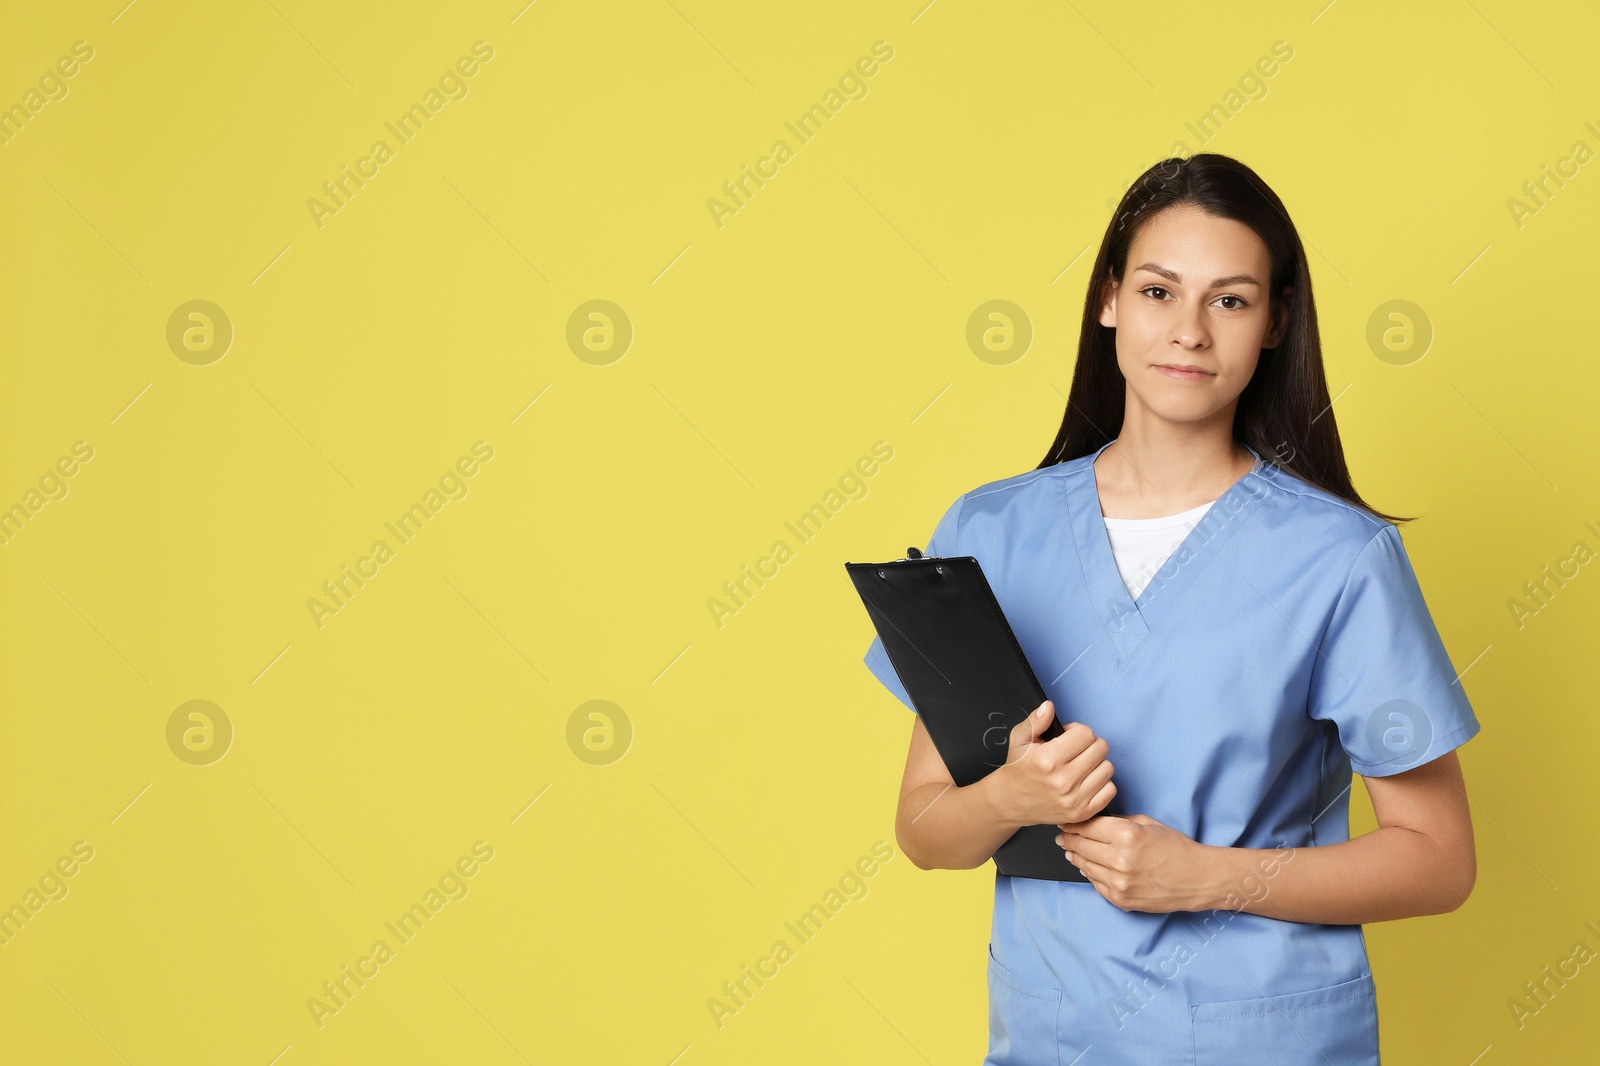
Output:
[1099, 203, 1288, 424]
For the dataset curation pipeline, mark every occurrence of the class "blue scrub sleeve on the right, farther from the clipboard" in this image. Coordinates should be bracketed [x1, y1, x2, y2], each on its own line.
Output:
[1307, 522, 1478, 778]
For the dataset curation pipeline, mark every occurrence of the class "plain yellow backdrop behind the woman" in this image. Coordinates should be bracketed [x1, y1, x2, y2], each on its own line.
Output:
[0, 0, 1600, 1066]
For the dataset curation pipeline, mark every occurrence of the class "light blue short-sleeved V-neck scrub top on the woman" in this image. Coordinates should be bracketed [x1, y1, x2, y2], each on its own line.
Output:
[866, 445, 1478, 1066]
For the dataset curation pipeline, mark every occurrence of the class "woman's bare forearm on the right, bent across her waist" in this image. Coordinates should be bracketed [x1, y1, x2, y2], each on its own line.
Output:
[1195, 826, 1477, 925]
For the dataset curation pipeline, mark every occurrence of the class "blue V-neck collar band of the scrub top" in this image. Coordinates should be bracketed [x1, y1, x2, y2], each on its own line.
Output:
[1058, 439, 1272, 663]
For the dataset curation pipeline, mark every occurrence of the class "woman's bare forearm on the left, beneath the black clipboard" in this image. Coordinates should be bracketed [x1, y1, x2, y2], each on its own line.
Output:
[894, 773, 1021, 869]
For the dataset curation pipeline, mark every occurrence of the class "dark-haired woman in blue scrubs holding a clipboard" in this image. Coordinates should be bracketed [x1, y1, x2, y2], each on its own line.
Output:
[866, 154, 1478, 1066]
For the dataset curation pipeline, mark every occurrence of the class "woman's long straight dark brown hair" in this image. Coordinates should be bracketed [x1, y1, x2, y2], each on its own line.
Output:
[1035, 152, 1411, 523]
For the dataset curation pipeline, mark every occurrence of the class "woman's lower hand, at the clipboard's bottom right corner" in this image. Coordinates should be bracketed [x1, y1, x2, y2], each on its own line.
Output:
[1056, 815, 1216, 914]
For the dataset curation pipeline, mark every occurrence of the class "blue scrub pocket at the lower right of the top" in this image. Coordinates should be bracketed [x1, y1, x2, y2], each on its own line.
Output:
[1189, 973, 1378, 1066]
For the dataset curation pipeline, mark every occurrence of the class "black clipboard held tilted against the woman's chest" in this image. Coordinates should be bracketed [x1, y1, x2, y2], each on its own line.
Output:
[845, 547, 1110, 884]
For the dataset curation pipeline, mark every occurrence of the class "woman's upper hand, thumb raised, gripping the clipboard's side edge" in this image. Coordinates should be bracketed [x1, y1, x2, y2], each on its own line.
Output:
[995, 699, 1117, 826]
